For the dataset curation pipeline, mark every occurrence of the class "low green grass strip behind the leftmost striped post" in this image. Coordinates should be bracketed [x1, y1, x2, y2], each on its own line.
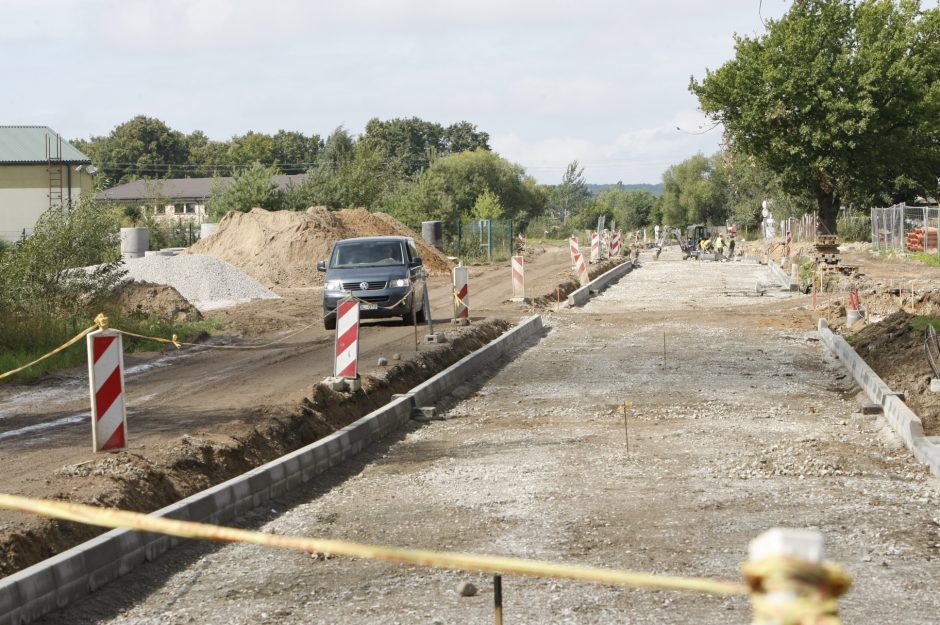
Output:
[0, 315, 222, 383]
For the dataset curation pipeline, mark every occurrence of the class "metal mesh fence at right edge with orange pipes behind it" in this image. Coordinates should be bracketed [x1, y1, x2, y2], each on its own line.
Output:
[871, 204, 940, 254]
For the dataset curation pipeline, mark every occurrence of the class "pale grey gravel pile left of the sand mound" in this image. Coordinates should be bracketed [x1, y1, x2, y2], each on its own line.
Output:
[119, 254, 278, 311]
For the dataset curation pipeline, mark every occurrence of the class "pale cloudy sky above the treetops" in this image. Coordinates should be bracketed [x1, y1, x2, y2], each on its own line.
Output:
[0, 0, 790, 183]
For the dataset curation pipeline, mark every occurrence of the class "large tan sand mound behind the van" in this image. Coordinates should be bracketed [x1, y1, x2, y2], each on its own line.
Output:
[187, 206, 451, 288]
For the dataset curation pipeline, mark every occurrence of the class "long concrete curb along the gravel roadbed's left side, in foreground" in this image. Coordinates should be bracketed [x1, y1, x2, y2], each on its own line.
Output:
[0, 315, 543, 625]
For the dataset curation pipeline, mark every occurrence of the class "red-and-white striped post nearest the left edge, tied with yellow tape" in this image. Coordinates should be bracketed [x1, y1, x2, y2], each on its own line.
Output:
[86, 329, 127, 452]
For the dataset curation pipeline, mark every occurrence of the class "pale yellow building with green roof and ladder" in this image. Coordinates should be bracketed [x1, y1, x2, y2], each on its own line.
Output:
[0, 126, 94, 241]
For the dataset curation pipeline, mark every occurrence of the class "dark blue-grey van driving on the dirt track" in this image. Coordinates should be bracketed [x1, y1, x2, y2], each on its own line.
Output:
[317, 236, 427, 330]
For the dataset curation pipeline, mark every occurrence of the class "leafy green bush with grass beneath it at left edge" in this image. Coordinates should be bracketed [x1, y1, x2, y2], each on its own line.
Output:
[0, 197, 218, 381]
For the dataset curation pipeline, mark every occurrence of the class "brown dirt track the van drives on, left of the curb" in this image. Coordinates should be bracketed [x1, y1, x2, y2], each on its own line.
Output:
[0, 246, 608, 574]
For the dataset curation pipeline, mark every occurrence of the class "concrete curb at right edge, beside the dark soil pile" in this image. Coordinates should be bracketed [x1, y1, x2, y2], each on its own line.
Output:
[819, 319, 940, 476]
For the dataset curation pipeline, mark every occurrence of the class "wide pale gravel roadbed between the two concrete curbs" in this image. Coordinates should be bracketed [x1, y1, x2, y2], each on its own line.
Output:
[36, 249, 940, 625]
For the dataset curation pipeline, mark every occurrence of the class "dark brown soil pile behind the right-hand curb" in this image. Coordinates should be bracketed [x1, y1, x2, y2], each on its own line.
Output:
[847, 310, 940, 435]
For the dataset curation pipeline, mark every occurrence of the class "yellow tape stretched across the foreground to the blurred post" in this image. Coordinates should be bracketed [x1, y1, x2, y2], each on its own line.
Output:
[0, 494, 748, 595]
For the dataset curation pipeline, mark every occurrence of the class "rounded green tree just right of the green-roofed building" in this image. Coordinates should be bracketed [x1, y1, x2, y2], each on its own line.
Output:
[93, 115, 189, 184]
